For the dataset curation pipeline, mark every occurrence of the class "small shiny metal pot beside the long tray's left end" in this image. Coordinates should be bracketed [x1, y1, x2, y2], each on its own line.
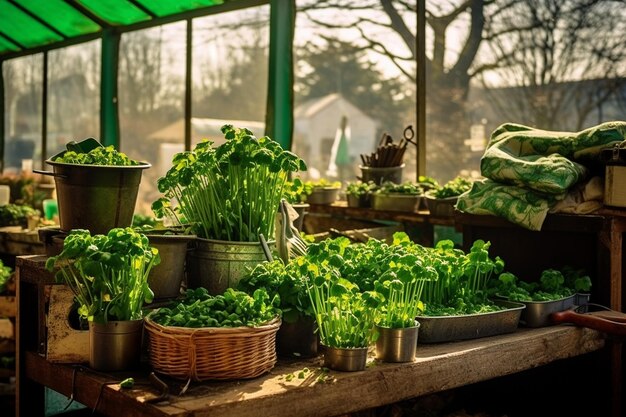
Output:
[376, 321, 420, 362]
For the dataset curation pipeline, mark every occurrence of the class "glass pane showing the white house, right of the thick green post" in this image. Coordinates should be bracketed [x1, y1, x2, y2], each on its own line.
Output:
[293, 0, 416, 182]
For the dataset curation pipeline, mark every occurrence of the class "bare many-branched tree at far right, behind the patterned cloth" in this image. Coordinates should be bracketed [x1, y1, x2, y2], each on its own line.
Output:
[476, 0, 626, 130]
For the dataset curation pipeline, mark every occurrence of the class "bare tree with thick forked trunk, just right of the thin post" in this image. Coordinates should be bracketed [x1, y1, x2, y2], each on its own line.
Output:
[299, 0, 498, 180]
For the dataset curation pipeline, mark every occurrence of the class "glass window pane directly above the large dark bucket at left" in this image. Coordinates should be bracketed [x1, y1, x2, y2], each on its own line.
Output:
[46, 41, 100, 158]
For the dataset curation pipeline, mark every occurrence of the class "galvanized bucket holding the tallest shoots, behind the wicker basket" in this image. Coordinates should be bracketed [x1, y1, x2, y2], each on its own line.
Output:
[187, 238, 275, 295]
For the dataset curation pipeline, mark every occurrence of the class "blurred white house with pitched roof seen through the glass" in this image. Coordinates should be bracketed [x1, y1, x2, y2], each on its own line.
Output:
[292, 93, 377, 178]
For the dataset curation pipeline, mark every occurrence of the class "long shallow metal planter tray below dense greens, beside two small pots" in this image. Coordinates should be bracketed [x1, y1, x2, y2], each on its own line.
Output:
[417, 300, 525, 343]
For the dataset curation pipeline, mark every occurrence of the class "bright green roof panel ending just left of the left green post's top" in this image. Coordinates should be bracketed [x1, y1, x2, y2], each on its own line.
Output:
[20, 0, 102, 37]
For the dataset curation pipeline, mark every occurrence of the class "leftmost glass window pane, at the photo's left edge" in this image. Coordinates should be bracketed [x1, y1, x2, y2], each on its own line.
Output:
[2, 54, 43, 174]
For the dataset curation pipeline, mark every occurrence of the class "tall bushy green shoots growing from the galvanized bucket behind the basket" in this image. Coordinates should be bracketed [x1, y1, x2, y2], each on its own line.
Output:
[153, 125, 306, 242]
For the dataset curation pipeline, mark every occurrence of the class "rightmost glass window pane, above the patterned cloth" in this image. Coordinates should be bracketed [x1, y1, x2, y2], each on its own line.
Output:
[426, 0, 626, 180]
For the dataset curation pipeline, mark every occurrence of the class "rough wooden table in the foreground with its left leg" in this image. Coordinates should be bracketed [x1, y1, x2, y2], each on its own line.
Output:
[17, 256, 605, 417]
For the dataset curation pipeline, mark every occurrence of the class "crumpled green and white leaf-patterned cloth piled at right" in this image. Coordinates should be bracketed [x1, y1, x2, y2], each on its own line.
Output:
[456, 121, 626, 230]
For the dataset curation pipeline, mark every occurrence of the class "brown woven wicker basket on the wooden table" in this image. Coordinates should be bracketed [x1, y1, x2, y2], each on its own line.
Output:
[145, 316, 281, 381]
